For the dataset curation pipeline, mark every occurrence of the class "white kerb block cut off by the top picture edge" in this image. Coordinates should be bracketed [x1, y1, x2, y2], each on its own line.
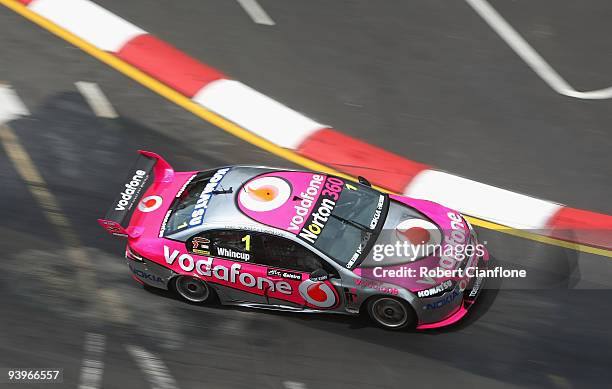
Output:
[28, 0, 146, 52]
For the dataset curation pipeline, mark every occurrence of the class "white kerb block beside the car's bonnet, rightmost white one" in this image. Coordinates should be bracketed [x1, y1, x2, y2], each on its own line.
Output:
[404, 170, 562, 229]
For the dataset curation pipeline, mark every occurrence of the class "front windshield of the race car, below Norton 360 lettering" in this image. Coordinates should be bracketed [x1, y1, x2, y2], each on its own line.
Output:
[314, 183, 388, 269]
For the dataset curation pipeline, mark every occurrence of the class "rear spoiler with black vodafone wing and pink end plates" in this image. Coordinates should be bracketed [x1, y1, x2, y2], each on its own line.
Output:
[98, 150, 174, 238]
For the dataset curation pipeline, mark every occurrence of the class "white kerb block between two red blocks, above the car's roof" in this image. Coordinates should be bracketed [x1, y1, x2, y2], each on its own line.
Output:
[193, 80, 326, 149]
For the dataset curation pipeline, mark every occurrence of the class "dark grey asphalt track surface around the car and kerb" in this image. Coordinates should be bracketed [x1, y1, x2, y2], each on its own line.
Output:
[0, 0, 612, 388]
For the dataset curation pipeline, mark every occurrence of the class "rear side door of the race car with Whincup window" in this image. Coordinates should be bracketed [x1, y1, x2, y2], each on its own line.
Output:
[185, 229, 273, 304]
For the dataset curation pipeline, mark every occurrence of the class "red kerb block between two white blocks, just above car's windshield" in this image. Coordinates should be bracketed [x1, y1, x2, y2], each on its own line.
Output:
[296, 128, 430, 193]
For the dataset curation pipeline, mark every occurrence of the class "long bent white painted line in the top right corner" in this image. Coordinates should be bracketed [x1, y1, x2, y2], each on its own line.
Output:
[465, 0, 612, 99]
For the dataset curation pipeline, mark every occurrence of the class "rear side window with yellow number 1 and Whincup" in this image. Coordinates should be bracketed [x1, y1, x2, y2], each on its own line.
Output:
[187, 230, 258, 262]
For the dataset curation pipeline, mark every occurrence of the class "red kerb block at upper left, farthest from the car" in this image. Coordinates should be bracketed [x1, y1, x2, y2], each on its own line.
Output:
[116, 34, 227, 97]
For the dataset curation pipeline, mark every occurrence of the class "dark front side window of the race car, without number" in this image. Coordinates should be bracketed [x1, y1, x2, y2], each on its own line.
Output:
[257, 234, 330, 273]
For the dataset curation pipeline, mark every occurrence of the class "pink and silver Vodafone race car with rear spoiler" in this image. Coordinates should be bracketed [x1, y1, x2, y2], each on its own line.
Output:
[98, 150, 489, 329]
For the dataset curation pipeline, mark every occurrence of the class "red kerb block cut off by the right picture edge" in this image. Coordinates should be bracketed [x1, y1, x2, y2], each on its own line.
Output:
[548, 207, 612, 249]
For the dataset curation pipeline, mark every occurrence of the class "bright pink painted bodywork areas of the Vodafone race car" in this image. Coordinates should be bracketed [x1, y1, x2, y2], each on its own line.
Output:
[99, 151, 489, 329]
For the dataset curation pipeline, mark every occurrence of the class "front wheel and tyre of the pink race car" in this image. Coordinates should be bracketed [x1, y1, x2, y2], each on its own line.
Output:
[367, 296, 417, 330]
